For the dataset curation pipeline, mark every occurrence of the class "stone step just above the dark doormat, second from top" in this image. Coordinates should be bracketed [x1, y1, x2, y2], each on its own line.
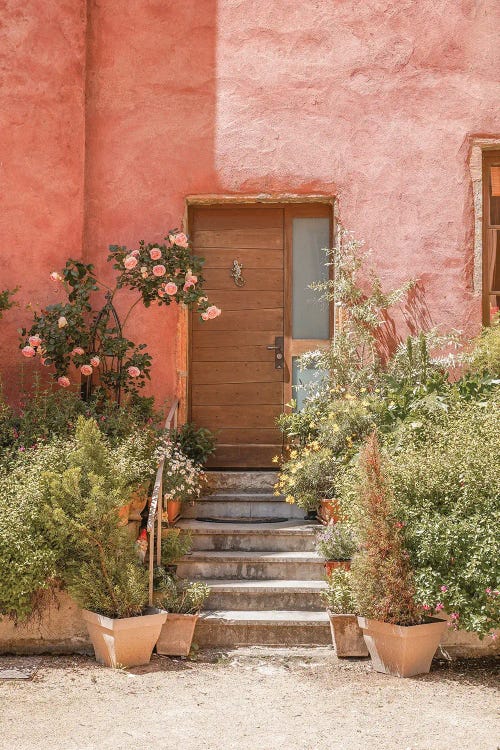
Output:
[182, 492, 305, 519]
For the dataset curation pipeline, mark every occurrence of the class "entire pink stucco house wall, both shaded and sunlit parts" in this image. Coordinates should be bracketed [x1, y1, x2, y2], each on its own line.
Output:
[0, 0, 500, 408]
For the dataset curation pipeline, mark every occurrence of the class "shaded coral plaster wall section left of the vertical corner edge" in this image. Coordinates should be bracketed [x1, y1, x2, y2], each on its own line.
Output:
[0, 0, 85, 406]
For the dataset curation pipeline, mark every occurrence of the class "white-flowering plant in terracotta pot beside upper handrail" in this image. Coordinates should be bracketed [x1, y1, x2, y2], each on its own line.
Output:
[161, 440, 204, 524]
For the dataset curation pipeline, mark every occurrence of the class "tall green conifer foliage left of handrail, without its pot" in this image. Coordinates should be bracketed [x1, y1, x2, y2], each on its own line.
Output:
[42, 417, 148, 618]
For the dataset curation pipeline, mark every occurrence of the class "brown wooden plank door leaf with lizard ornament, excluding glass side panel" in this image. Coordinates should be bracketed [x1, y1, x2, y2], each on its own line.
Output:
[190, 206, 285, 468]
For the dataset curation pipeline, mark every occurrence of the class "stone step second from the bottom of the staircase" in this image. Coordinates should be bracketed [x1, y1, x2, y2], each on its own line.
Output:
[201, 578, 326, 611]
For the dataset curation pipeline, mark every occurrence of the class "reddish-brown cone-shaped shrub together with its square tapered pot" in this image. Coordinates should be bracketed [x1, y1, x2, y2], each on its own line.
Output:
[352, 433, 447, 677]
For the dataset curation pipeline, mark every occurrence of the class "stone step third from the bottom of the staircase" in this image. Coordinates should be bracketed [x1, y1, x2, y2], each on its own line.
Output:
[177, 550, 324, 581]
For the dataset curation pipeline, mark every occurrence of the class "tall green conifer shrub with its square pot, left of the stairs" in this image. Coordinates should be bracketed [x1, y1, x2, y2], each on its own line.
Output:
[42, 417, 167, 667]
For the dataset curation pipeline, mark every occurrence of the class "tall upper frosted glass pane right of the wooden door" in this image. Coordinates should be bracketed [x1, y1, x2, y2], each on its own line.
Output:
[292, 219, 330, 339]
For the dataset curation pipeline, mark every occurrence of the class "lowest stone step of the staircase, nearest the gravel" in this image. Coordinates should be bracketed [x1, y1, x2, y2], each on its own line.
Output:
[194, 610, 331, 648]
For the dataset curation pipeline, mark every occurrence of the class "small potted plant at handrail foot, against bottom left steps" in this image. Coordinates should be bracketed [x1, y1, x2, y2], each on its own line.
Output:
[155, 569, 210, 656]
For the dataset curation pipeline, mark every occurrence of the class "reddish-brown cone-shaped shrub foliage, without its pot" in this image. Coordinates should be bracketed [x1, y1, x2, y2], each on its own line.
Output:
[351, 433, 422, 625]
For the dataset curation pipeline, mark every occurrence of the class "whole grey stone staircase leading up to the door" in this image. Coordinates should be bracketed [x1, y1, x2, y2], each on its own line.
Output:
[177, 471, 331, 648]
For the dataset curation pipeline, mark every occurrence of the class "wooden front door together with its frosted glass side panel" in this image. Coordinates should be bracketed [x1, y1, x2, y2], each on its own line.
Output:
[189, 204, 333, 468]
